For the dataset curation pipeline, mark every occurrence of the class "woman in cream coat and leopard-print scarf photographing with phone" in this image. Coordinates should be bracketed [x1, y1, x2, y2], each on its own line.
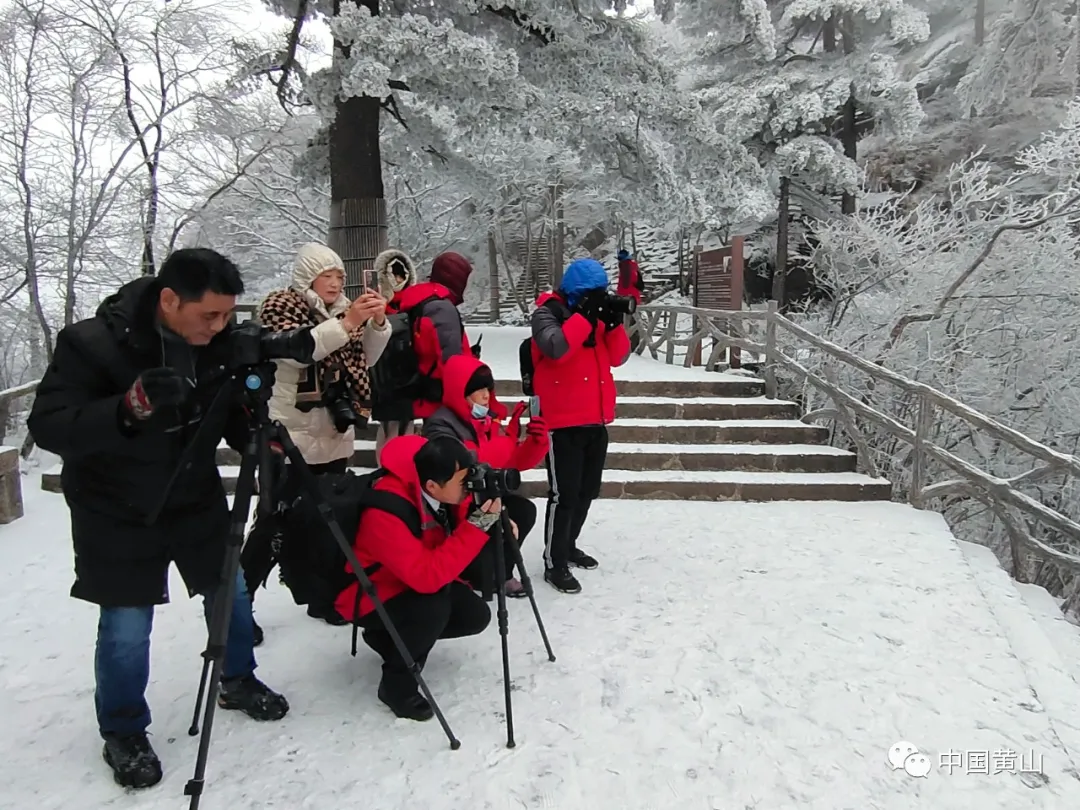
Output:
[241, 242, 390, 643]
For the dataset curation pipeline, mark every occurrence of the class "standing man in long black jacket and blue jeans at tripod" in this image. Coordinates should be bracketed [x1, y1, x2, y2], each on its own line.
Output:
[29, 248, 288, 787]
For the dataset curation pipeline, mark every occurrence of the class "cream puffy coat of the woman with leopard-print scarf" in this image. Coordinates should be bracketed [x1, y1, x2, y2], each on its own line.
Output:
[261, 262, 390, 464]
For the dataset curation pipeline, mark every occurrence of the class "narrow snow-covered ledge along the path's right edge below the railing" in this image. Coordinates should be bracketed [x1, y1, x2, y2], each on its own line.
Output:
[957, 540, 1080, 773]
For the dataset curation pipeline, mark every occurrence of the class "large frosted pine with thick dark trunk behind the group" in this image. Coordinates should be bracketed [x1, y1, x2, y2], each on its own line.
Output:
[252, 0, 768, 298]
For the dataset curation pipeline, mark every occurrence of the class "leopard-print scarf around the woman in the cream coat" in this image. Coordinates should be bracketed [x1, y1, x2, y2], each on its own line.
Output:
[258, 289, 372, 418]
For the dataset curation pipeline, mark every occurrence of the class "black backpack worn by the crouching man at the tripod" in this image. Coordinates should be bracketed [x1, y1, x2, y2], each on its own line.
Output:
[279, 470, 421, 605]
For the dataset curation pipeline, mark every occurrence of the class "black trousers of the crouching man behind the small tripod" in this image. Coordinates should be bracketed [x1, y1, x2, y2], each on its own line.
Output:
[360, 582, 491, 698]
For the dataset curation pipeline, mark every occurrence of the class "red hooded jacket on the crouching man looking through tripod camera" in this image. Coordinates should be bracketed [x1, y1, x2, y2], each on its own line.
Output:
[335, 435, 488, 620]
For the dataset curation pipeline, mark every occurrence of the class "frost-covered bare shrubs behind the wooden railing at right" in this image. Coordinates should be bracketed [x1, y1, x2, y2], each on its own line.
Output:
[804, 102, 1080, 593]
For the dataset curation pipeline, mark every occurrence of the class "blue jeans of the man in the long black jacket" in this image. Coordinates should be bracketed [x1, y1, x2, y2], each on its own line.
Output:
[94, 571, 255, 734]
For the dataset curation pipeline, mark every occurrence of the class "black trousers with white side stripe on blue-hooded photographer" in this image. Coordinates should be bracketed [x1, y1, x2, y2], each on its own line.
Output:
[543, 424, 608, 568]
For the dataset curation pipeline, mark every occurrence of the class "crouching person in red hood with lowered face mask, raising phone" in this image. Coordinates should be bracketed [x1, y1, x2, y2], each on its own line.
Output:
[423, 354, 549, 598]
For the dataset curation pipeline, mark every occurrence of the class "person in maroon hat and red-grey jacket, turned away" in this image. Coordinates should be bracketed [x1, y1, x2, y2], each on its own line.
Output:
[387, 253, 472, 419]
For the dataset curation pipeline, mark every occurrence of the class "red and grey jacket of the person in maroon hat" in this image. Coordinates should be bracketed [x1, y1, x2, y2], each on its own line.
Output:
[387, 281, 471, 419]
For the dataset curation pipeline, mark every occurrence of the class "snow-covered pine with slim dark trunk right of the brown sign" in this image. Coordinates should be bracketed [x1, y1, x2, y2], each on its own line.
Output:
[676, 0, 929, 300]
